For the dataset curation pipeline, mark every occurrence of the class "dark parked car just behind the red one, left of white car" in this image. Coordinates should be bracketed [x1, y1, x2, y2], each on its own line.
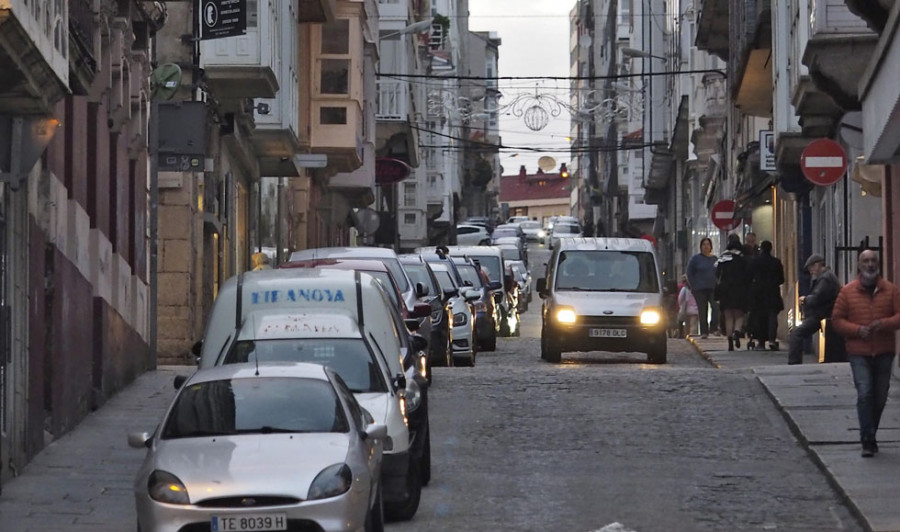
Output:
[400, 254, 453, 375]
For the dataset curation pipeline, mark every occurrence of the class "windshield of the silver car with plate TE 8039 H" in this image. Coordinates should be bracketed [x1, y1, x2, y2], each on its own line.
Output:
[162, 377, 350, 440]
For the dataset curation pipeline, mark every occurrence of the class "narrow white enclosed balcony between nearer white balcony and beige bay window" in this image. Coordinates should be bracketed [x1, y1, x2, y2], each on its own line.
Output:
[250, 3, 300, 176]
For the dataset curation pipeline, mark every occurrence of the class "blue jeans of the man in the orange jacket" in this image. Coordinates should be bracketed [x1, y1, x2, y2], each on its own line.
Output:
[848, 353, 894, 441]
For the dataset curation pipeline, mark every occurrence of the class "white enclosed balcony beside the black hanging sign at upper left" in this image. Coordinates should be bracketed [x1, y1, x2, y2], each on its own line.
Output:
[200, 0, 282, 99]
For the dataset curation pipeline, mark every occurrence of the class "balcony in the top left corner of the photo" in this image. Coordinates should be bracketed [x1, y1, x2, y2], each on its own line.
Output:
[0, 0, 70, 114]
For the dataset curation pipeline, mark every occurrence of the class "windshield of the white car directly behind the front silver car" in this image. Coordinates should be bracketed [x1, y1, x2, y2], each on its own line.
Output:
[223, 338, 387, 393]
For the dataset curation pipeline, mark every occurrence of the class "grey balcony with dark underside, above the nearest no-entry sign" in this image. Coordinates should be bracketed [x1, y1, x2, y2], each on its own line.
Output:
[802, 0, 878, 111]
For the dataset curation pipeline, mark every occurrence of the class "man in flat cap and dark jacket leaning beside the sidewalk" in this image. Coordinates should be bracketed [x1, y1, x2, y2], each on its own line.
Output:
[788, 253, 841, 365]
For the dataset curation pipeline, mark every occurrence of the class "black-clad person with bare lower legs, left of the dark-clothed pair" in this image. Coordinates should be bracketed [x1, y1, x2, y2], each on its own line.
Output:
[715, 235, 750, 351]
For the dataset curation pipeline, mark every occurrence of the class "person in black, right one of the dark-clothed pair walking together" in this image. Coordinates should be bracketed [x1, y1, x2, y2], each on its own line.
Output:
[747, 240, 784, 351]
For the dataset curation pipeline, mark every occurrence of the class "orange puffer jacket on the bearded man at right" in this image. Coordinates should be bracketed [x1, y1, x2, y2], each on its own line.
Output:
[831, 279, 900, 356]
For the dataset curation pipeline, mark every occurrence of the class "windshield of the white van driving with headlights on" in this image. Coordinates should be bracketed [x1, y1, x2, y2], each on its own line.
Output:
[555, 250, 659, 293]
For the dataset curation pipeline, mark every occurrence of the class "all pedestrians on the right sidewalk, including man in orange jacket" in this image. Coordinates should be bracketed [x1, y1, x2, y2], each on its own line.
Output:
[678, 235, 900, 458]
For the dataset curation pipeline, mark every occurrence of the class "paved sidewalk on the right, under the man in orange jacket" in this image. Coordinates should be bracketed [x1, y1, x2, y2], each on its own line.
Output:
[691, 337, 900, 532]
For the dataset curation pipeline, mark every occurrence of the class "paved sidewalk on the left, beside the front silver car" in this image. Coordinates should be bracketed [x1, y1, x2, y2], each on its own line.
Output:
[0, 367, 194, 532]
